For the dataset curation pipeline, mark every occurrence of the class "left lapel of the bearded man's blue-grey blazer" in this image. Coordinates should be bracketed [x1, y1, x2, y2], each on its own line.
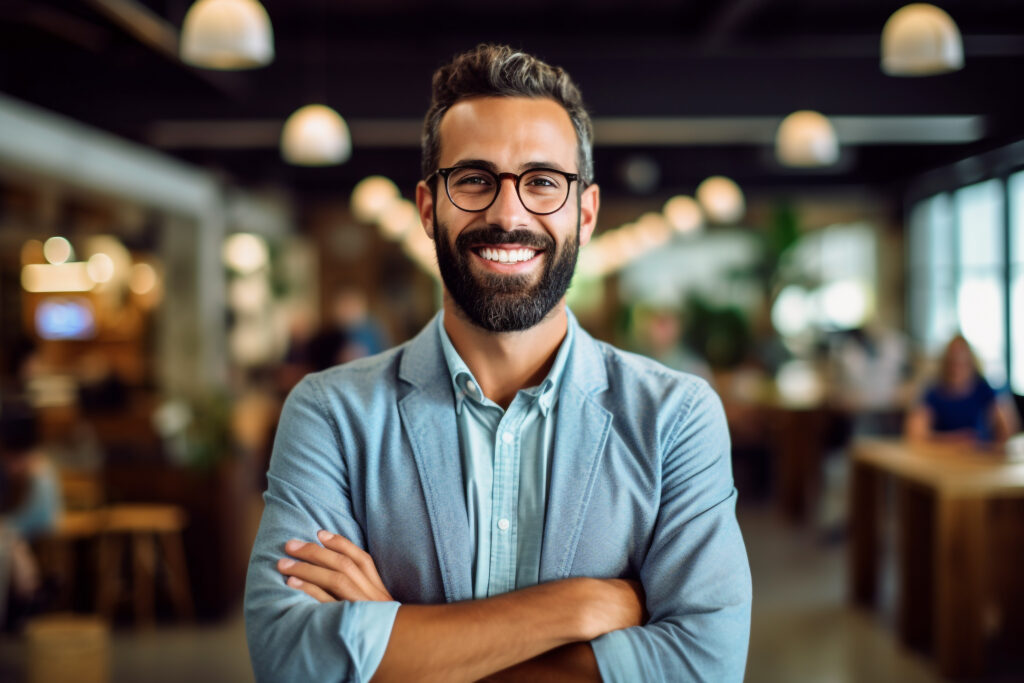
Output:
[395, 316, 473, 601]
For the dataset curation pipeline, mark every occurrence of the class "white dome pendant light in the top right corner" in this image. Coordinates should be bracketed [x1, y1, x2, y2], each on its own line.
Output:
[882, 2, 964, 76]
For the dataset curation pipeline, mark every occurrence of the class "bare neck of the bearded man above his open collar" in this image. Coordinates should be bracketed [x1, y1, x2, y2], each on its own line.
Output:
[443, 292, 568, 408]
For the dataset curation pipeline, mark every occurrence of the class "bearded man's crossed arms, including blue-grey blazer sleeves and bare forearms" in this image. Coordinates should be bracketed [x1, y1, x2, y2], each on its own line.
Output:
[246, 374, 751, 681]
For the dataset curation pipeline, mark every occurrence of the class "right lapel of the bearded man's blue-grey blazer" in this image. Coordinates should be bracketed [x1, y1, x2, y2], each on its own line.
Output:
[541, 313, 611, 581]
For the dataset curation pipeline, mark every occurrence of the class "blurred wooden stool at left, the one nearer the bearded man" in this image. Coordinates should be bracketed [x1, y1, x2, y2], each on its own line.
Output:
[96, 505, 194, 627]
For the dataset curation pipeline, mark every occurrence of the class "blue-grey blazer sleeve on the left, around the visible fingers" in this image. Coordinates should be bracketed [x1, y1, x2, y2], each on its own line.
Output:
[245, 376, 398, 681]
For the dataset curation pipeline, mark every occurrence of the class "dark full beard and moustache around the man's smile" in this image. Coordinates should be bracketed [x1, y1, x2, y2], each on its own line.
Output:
[434, 213, 580, 332]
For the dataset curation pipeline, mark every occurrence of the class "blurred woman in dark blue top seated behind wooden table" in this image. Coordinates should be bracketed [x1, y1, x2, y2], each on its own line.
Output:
[904, 336, 1017, 443]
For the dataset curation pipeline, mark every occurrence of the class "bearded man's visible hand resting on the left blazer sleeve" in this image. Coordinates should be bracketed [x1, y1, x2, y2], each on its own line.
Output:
[278, 531, 394, 602]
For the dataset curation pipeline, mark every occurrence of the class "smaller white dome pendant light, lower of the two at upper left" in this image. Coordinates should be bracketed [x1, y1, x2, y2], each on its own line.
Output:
[281, 104, 352, 166]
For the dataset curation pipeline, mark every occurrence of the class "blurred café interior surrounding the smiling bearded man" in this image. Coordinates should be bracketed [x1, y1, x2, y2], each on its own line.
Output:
[0, 0, 1024, 683]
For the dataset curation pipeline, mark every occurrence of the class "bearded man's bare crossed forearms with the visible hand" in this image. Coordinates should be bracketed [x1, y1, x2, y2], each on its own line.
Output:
[278, 531, 643, 681]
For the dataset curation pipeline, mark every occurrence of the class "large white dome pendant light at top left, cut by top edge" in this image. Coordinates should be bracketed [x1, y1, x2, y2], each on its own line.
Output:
[180, 0, 273, 71]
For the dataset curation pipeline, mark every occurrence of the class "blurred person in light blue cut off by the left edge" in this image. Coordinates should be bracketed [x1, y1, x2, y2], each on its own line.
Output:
[0, 401, 61, 624]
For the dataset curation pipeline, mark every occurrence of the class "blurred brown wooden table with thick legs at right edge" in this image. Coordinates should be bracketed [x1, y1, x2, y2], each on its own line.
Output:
[850, 439, 1024, 677]
